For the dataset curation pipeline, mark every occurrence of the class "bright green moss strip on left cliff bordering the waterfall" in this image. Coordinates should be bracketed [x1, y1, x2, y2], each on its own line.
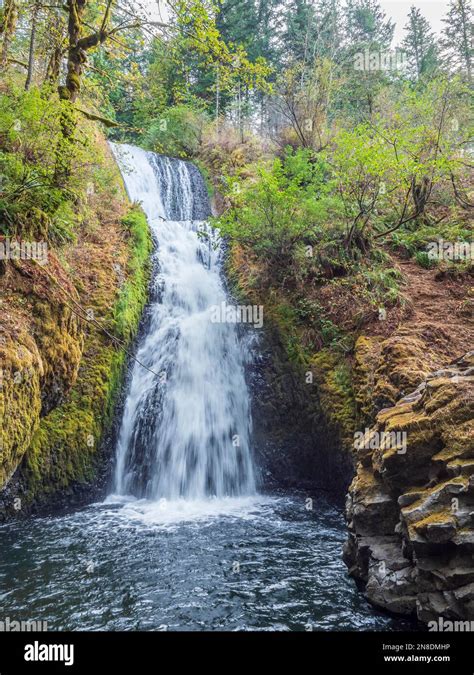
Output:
[18, 207, 152, 504]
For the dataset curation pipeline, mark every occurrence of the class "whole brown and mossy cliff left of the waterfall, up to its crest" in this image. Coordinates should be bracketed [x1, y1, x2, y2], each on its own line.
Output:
[0, 144, 151, 520]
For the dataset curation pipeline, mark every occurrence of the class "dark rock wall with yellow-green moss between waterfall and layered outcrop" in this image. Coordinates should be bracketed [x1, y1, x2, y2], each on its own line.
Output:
[227, 246, 356, 494]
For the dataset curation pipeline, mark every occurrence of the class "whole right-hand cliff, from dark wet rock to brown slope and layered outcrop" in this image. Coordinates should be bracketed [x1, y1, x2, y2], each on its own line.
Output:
[229, 236, 474, 622]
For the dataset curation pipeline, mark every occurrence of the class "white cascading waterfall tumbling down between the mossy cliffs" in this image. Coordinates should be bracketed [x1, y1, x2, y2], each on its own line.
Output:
[112, 144, 255, 500]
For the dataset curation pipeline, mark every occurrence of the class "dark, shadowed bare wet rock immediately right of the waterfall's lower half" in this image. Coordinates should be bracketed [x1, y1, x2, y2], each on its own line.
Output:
[247, 328, 354, 499]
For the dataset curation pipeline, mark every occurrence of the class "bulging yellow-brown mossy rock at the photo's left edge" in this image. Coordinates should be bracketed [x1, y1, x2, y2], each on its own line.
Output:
[0, 259, 83, 487]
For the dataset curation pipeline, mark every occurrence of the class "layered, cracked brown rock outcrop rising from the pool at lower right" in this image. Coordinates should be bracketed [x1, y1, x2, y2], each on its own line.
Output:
[344, 352, 474, 622]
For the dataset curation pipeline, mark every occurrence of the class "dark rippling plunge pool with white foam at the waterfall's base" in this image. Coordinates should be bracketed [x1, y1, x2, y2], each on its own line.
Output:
[0, 494, 407, 631]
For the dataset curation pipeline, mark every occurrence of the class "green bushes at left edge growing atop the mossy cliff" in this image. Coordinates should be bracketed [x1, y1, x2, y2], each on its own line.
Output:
[0, 86, 103, 240]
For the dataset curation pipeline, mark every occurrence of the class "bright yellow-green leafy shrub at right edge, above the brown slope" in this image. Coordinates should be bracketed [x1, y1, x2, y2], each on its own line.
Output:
[331, 77, 470, 244]
